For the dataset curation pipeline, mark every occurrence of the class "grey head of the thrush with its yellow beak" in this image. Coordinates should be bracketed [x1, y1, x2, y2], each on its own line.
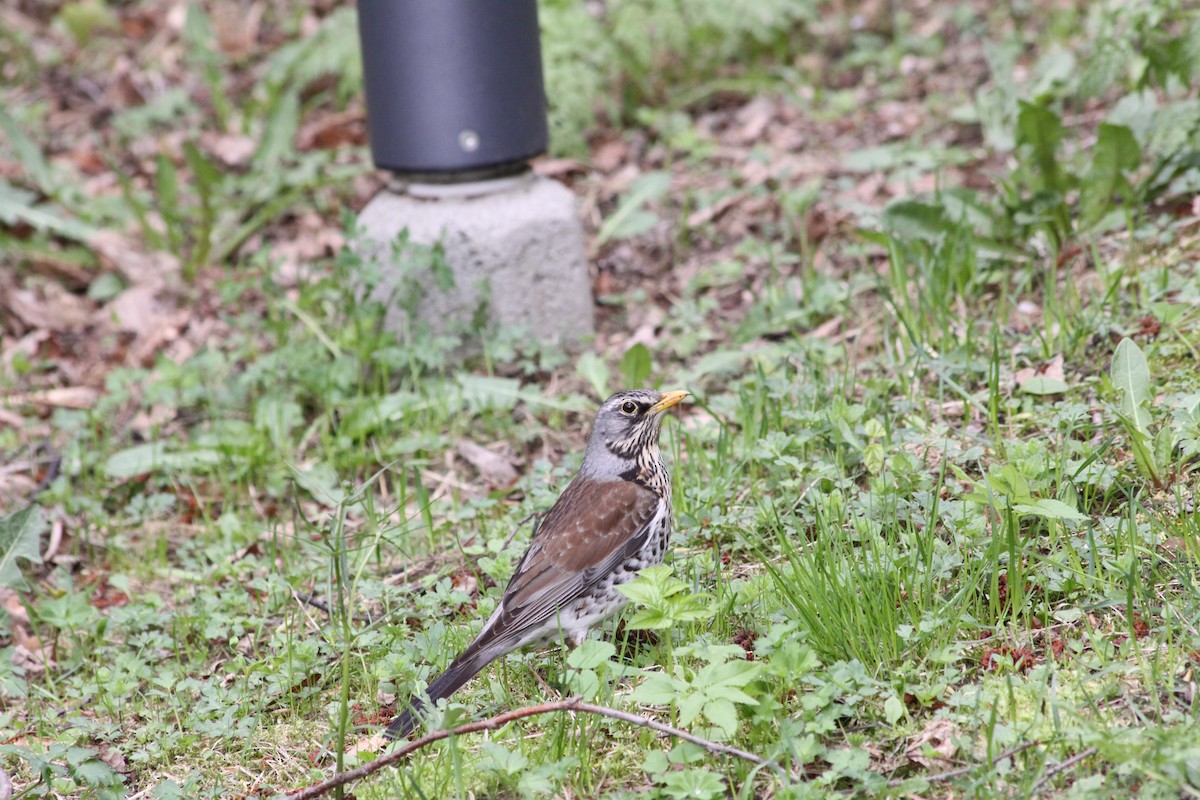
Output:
[582, 389, 688, 480]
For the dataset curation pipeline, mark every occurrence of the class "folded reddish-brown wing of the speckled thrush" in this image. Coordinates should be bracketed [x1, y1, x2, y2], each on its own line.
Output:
[496, 477, 659, 632]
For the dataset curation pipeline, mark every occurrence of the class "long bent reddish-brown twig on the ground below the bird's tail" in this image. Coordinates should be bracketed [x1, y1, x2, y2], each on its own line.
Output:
[287, 698, 788, 800]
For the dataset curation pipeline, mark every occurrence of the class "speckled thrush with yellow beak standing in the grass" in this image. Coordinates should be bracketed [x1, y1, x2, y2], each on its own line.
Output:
[384, 389, 689, 740]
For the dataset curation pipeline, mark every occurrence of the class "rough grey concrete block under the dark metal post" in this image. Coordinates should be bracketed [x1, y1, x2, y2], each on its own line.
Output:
[359, 173, 595, 342]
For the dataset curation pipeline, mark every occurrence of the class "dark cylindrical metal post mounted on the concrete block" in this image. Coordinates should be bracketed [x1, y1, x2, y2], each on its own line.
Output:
[358, 0, 547, 181]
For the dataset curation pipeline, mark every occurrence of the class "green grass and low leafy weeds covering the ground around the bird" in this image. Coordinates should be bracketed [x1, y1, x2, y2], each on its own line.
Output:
[0, 1, 1200, 799]
